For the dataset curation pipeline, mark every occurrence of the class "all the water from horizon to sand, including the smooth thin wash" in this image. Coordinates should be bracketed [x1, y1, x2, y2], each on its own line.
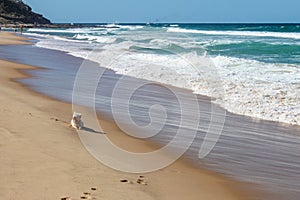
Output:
[0, 24, 300, 200]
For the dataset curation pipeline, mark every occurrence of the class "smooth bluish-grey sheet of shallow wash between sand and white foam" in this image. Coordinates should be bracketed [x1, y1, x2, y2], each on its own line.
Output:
[0, 45, 300, 200]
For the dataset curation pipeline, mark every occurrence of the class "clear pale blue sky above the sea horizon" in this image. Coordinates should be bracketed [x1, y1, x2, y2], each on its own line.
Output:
[23, 0, 300, 23]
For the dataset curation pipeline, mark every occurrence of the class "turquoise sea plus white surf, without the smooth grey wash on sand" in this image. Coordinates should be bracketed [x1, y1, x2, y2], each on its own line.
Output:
[25, 24, 300, 125]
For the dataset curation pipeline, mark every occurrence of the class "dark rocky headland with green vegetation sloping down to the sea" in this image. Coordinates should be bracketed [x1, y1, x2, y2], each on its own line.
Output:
[0, 0, 51, 25]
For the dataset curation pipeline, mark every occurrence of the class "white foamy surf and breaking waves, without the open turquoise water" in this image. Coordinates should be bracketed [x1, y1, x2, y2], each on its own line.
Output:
[25, 26, 300, 125]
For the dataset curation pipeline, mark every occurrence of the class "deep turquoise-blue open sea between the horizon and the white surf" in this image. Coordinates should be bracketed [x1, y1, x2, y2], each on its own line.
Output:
[24, 24, 300, 64]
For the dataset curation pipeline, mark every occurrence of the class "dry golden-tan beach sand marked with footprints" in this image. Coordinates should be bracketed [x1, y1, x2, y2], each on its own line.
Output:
[0, 33, 245, 200]
